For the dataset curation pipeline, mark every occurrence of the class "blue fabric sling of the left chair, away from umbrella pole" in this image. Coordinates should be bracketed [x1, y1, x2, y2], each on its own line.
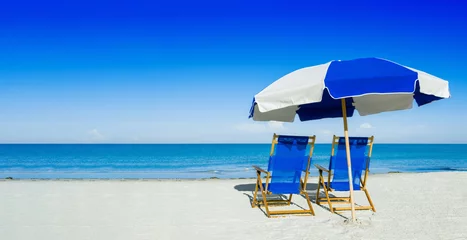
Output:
[268, 134, 315, 194]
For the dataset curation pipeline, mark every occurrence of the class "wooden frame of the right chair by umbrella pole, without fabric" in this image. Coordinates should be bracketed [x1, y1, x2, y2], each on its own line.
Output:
[315, 135, 376, 213]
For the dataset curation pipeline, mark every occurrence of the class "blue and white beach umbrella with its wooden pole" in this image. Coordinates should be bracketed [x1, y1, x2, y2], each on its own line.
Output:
[250, 58, 450, 221]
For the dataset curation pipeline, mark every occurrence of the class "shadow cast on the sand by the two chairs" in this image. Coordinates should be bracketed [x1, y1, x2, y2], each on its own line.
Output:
[234, 183, 348, 219]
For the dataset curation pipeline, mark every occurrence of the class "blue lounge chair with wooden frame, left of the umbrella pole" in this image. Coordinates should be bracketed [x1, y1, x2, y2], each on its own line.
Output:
[252, 134, 316, 217]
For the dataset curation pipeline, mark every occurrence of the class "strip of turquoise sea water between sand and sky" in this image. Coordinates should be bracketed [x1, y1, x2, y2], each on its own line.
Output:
[0, 144, 467, 178]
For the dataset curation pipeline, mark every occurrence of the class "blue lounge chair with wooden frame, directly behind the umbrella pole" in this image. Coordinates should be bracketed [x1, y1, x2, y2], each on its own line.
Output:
[315, 136, 376, 213]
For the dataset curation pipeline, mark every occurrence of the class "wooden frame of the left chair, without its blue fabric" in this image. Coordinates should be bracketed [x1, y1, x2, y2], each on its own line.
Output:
[251, 133, 316, 217]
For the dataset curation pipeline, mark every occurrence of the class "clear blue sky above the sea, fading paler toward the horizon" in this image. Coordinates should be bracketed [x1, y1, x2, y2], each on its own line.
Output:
[0, 0, 467, 143]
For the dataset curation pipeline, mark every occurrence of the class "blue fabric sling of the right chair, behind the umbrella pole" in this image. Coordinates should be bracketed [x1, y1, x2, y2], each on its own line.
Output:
[329, 136, 373, 191]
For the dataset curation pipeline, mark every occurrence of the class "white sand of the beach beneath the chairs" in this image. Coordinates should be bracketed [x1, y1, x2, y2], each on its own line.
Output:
[0, 172, 467, 240]
